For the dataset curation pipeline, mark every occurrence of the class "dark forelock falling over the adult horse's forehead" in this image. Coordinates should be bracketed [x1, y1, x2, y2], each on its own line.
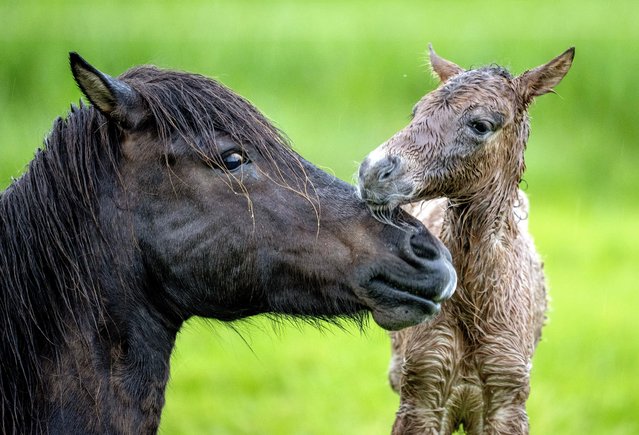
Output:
[119, 66, 319, 218]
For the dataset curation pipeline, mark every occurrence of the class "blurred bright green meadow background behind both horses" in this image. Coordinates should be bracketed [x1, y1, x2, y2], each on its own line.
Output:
[0, 0, 639, 434]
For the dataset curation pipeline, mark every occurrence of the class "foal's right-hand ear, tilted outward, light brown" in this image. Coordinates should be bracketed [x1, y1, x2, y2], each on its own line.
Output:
[515, 47, 575, 104]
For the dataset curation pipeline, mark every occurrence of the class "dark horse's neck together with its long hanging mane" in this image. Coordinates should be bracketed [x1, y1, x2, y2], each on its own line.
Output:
[0, 111, 179, 433]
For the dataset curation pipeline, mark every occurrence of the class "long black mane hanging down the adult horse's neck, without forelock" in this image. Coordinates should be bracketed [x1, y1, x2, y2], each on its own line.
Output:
[0, 105, 120, 433]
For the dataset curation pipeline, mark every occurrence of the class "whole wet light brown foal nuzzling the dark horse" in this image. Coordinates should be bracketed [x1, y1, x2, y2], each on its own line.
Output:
[360, 49, 574, 434]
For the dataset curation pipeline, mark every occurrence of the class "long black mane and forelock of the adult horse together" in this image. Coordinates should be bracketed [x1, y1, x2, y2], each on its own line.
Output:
[0, 66, 303, 433]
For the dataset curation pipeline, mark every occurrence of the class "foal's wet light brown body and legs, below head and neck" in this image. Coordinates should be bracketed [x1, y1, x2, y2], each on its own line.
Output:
[390, 191, 546, 434]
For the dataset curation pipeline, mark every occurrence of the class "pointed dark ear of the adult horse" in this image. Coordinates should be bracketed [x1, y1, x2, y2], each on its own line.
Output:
[69, 52, 141, 128]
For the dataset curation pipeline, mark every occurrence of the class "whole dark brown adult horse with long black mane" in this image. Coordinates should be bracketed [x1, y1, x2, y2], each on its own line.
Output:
[0, 54, 455, 434]
